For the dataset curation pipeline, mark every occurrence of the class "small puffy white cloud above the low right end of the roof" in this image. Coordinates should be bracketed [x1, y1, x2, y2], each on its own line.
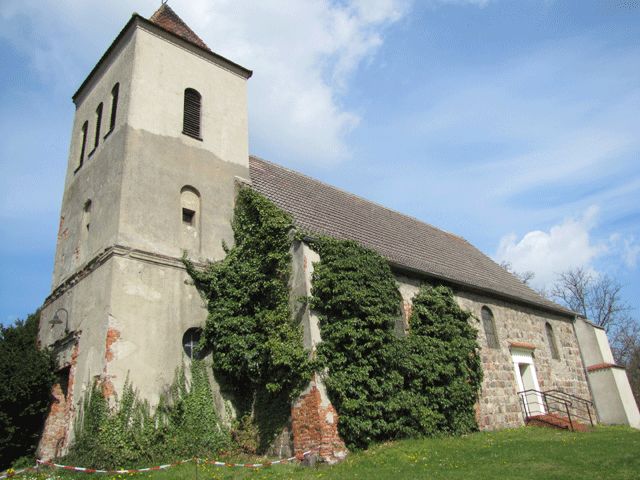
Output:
[496, 206, 608, 288]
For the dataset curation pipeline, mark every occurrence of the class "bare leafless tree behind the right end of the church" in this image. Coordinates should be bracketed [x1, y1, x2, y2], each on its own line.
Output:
[549, 268, 640, 405]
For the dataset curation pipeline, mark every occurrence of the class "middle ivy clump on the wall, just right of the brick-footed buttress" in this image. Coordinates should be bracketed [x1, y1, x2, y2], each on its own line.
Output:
[311, 238, 403, 448]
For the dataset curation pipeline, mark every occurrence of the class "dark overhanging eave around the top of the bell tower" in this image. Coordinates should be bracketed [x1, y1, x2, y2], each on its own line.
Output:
[71, 13, 253, 103]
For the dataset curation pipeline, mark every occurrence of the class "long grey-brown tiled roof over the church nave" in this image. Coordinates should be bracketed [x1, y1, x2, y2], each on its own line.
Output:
[249, 157, 572, 315]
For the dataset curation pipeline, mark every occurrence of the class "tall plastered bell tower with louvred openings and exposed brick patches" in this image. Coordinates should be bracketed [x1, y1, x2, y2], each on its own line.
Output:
[39, 4, 252, 458]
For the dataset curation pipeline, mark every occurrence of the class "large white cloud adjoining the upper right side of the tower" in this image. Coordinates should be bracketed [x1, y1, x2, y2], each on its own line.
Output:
[199, 0, 409, 163]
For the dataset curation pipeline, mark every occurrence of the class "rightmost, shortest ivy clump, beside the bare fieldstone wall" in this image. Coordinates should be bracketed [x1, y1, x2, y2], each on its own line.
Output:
[394, 285, 482, 436]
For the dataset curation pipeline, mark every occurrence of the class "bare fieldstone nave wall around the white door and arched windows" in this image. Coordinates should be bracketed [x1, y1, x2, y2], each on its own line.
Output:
[396, 275, 591, 430]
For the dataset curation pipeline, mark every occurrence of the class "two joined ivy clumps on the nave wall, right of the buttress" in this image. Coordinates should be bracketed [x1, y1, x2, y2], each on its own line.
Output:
[311, 238, 482, 448]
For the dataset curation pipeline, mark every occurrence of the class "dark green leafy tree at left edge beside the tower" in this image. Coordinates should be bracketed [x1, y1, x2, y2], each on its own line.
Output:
[0, 311, 54, 470]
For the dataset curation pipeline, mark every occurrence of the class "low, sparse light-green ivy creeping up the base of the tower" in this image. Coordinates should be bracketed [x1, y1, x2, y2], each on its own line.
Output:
[67, 361, 230, 468]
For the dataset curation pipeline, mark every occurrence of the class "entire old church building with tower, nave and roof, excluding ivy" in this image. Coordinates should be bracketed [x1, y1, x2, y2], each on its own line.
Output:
[39, 4, 640, 461]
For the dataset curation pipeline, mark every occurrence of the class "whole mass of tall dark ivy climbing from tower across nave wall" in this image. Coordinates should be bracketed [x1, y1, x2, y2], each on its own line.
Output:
[185, 189, 482, 451]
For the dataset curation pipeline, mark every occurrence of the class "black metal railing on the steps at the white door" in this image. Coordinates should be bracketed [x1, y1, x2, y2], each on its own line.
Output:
[518, 389, 593, 430]
